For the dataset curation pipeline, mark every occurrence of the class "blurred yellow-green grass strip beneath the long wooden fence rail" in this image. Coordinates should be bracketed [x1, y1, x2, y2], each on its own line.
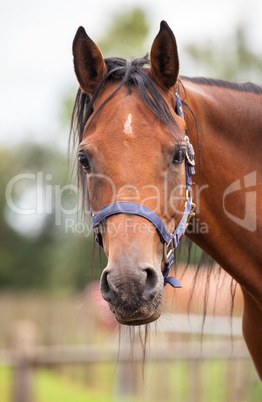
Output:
[0, 360, 262, 402]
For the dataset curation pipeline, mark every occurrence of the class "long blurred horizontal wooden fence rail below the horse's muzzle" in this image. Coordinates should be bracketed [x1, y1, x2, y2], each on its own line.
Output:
[0, 341, 250, 367]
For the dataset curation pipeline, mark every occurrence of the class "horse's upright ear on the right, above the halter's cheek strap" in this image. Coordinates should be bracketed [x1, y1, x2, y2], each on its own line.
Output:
[150, 21, 179, 89]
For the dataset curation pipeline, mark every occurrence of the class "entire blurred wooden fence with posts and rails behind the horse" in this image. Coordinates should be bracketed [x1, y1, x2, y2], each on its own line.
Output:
[0, 315, 262, 402]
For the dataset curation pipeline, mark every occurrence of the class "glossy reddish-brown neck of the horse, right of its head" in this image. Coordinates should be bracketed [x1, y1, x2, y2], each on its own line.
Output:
[184, 81, 262, 297]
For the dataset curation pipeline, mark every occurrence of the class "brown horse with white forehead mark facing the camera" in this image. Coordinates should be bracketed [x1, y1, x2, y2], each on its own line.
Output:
[72, 22, 262, 378]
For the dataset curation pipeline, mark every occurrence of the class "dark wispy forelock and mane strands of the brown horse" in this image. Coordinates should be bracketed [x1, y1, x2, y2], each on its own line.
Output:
[69, 55, 235, 325]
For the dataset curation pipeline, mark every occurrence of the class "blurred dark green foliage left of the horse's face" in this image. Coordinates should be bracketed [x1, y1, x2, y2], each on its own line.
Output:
[0, 143, 105, 291]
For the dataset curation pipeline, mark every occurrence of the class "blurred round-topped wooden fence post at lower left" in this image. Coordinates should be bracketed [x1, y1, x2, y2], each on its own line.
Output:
[11, 321, 36, 402]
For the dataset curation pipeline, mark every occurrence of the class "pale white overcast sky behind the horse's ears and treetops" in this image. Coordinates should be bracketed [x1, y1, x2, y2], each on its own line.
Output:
[0, 0, 262, 147]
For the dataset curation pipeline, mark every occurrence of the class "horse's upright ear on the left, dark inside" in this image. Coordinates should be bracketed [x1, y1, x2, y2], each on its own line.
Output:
[73, 27, 107, 95]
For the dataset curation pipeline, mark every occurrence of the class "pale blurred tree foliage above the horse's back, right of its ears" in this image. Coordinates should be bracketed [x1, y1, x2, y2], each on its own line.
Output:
[185, 26, 262, 83]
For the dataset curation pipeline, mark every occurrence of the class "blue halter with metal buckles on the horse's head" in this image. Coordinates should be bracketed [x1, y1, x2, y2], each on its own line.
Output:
[91, 92, 195, 288]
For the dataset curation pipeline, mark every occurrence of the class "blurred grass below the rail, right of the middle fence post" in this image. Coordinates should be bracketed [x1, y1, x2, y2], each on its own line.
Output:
[145, 359, 262, 402]
